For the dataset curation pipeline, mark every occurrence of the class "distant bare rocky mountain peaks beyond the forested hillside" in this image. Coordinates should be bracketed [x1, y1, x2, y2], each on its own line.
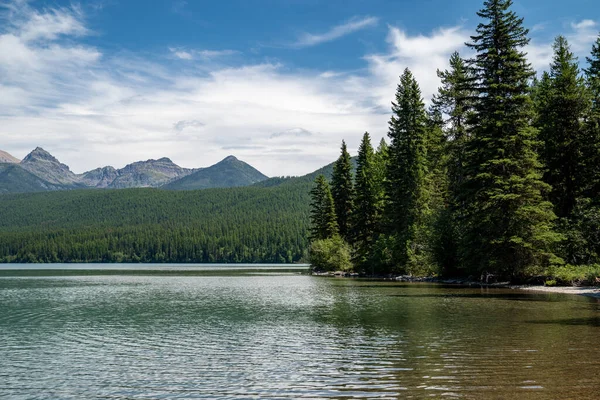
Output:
[0, 147, 268, 193]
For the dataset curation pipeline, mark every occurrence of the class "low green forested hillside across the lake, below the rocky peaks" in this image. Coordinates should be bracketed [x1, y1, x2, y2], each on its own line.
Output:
[0, 182, 311, 262]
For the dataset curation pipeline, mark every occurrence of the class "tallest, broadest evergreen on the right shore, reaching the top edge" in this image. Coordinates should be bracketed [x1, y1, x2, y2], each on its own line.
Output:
[462, 0, 559, 277]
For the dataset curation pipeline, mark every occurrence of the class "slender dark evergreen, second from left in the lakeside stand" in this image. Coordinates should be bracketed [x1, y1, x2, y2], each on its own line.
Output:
[331, 140, 354, 240]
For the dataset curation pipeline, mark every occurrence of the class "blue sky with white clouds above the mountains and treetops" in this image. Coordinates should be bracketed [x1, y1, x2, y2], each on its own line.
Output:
[0, 0, 600, 176]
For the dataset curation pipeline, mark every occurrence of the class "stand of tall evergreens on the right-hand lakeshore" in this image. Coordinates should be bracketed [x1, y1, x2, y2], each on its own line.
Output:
[310, 0, 600, 284]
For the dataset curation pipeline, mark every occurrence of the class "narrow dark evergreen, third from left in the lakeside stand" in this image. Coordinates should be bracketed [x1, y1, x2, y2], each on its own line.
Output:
[352, 132, 378, 267]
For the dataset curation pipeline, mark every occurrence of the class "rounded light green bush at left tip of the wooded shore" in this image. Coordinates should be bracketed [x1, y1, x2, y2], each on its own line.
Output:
[308, 235, 352, 272]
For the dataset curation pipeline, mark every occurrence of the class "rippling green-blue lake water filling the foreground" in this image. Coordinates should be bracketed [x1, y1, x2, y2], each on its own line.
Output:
[0, 266, 600, 399]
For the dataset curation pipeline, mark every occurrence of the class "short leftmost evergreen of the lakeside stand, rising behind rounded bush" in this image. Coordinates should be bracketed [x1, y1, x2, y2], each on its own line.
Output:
[310, 175, 339, 241]
